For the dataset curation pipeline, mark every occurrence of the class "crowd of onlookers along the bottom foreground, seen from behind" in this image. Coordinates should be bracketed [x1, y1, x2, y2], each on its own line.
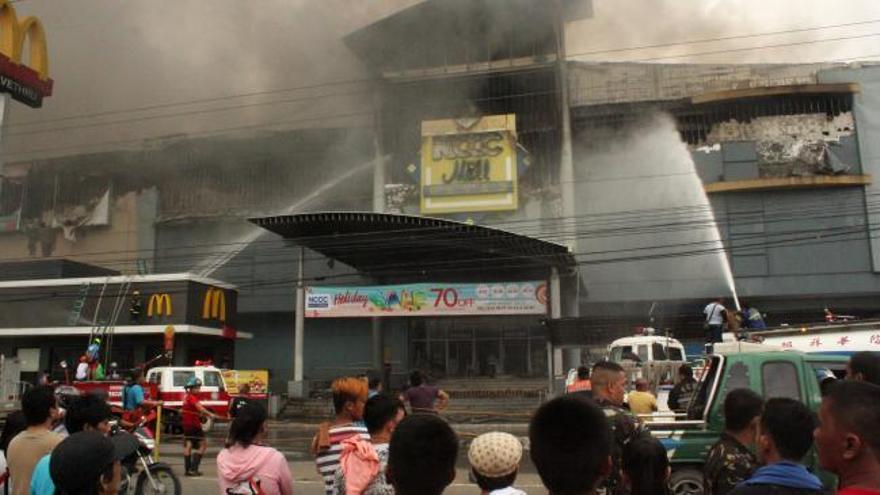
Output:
[0, 353, 880, 495]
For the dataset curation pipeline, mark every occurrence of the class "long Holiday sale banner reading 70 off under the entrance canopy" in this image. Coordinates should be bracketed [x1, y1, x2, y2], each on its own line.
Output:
[305, 281, 548, 318]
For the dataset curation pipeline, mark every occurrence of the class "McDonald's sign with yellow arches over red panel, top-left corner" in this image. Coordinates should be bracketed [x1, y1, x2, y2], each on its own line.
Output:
[0, 0, 53, 108]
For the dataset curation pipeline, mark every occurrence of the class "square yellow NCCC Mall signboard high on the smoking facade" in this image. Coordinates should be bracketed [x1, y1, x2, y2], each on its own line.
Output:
[421, 114, 517, 214]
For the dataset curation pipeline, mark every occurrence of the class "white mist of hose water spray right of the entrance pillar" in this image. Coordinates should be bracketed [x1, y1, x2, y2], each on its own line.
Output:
[575, 115, 730, 302]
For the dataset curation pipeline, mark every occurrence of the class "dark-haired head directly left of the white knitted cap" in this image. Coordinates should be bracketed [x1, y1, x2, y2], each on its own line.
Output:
[385, 414, 458, 495]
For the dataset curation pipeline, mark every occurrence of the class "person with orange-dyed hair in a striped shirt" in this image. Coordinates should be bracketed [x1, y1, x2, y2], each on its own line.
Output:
[312, 377, 370, 495]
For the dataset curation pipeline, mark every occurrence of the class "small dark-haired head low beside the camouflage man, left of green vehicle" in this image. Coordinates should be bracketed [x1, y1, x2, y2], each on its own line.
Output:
[620, 436, 672, 495]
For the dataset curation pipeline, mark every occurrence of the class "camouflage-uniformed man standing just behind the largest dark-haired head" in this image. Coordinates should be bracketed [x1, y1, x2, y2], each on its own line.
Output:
[591, 361, 650, 495]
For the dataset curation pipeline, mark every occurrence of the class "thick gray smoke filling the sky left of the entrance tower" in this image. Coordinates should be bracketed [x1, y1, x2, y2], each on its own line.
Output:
[4, 0, 416, 161]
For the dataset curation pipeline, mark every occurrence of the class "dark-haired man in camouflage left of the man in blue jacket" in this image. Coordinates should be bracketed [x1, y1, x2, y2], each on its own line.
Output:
[703, 388, 764, 495]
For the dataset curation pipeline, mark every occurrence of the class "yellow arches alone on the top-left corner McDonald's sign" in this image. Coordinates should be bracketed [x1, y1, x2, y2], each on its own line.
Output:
[0, 0, 49, 80]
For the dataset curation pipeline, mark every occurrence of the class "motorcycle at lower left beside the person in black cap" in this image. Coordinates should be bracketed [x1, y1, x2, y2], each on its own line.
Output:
[110, 424, 181, 495]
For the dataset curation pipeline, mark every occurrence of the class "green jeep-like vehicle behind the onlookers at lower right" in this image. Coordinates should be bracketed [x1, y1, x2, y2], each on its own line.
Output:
[648, 351, 847, 494]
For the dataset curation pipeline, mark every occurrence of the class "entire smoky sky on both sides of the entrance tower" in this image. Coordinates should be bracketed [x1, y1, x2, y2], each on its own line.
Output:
[2, 0, 880, 162]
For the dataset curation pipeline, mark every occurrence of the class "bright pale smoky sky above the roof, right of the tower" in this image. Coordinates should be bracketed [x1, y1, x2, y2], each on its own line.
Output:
[567, 0, 880, 63]
